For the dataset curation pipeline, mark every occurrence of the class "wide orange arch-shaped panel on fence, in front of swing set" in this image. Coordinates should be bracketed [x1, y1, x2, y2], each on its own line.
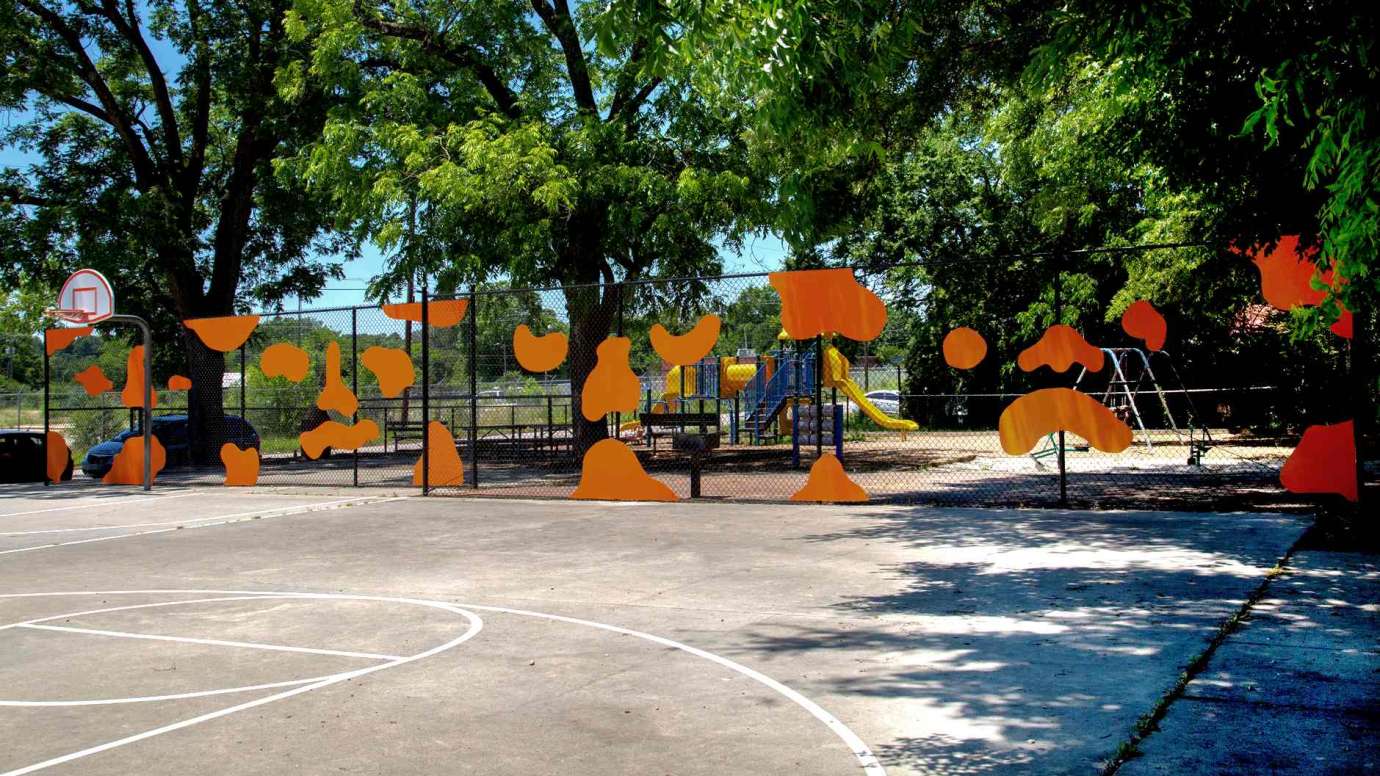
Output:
[996, 388, 1132, 456]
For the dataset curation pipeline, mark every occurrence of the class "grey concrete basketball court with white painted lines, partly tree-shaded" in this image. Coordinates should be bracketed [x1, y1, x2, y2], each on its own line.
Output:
[0, 486, 1307, 775]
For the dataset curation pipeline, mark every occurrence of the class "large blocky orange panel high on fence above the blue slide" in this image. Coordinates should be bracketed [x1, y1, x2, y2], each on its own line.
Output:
[767, 269, 886, 342]
